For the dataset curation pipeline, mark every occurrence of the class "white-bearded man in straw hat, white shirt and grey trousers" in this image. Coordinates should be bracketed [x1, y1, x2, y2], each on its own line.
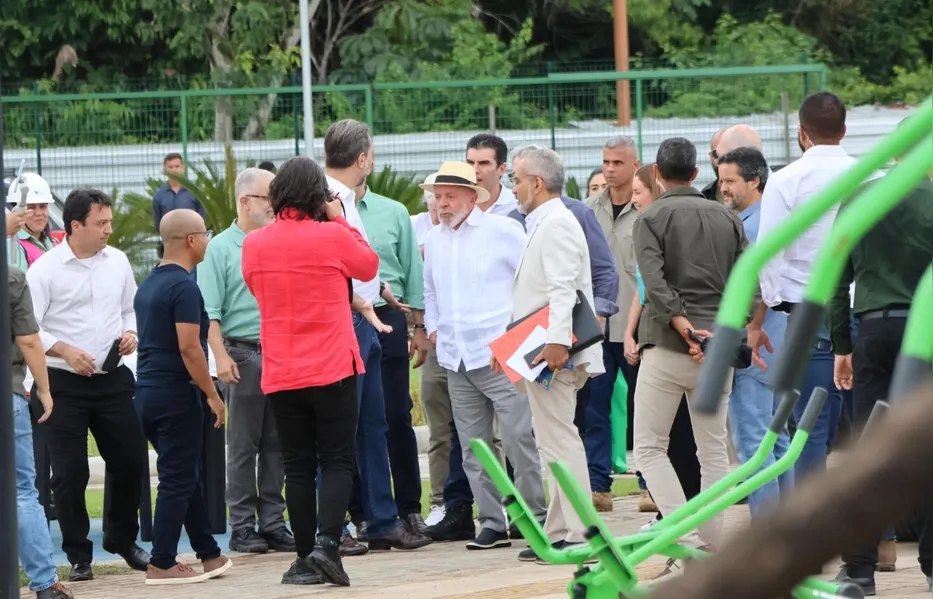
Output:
[424, 162, 545, 549]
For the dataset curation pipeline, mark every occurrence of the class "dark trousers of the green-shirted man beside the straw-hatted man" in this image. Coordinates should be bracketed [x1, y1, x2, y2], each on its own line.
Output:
[376, 308, 421, 518]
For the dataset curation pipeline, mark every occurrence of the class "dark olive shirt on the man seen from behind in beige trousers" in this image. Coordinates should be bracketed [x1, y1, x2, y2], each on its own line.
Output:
[633, 187, 748, 353]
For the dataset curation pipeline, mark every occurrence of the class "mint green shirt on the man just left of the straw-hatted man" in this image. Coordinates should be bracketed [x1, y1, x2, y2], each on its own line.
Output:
[356, 189, 424, 310]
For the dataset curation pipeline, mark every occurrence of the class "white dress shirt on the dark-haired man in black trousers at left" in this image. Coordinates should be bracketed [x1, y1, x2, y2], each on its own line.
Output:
[26, 241, 136, 372]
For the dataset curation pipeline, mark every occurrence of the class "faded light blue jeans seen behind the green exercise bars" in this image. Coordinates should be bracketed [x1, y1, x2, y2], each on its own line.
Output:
[729, 310, 794, 517]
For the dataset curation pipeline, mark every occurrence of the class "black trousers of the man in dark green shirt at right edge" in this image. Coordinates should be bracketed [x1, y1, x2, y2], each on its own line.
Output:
[842, 318, 933, 578]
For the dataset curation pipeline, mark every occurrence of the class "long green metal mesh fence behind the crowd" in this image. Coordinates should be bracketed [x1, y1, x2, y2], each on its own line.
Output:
[2, 64, 827, 195]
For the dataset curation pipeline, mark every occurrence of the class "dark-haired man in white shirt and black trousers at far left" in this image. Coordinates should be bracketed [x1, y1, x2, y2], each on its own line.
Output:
[26, 189, 149, 581]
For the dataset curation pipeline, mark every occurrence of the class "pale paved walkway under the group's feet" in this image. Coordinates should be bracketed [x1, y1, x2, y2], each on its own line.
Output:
[32, 498, 930, 599]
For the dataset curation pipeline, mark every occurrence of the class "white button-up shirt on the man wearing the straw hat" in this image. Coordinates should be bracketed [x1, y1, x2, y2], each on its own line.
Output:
[424, 208, 526, 371]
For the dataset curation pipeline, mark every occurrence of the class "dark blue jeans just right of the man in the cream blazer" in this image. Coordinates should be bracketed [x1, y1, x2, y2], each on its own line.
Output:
[577, 341, 634, 493]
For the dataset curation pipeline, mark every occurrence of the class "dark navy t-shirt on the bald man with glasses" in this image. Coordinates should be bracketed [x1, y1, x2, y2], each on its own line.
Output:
[133, 264, 210, 387]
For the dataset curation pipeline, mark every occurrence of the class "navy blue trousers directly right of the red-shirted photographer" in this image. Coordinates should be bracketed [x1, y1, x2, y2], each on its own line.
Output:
[350, 312, 399, 537]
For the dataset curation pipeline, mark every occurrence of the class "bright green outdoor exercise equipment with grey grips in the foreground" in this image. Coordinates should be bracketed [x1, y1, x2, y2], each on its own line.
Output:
[470, 98, 933, 599]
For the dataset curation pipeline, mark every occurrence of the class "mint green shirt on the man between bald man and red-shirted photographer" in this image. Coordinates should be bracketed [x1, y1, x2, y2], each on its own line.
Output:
[198, 221, 259, 341]
